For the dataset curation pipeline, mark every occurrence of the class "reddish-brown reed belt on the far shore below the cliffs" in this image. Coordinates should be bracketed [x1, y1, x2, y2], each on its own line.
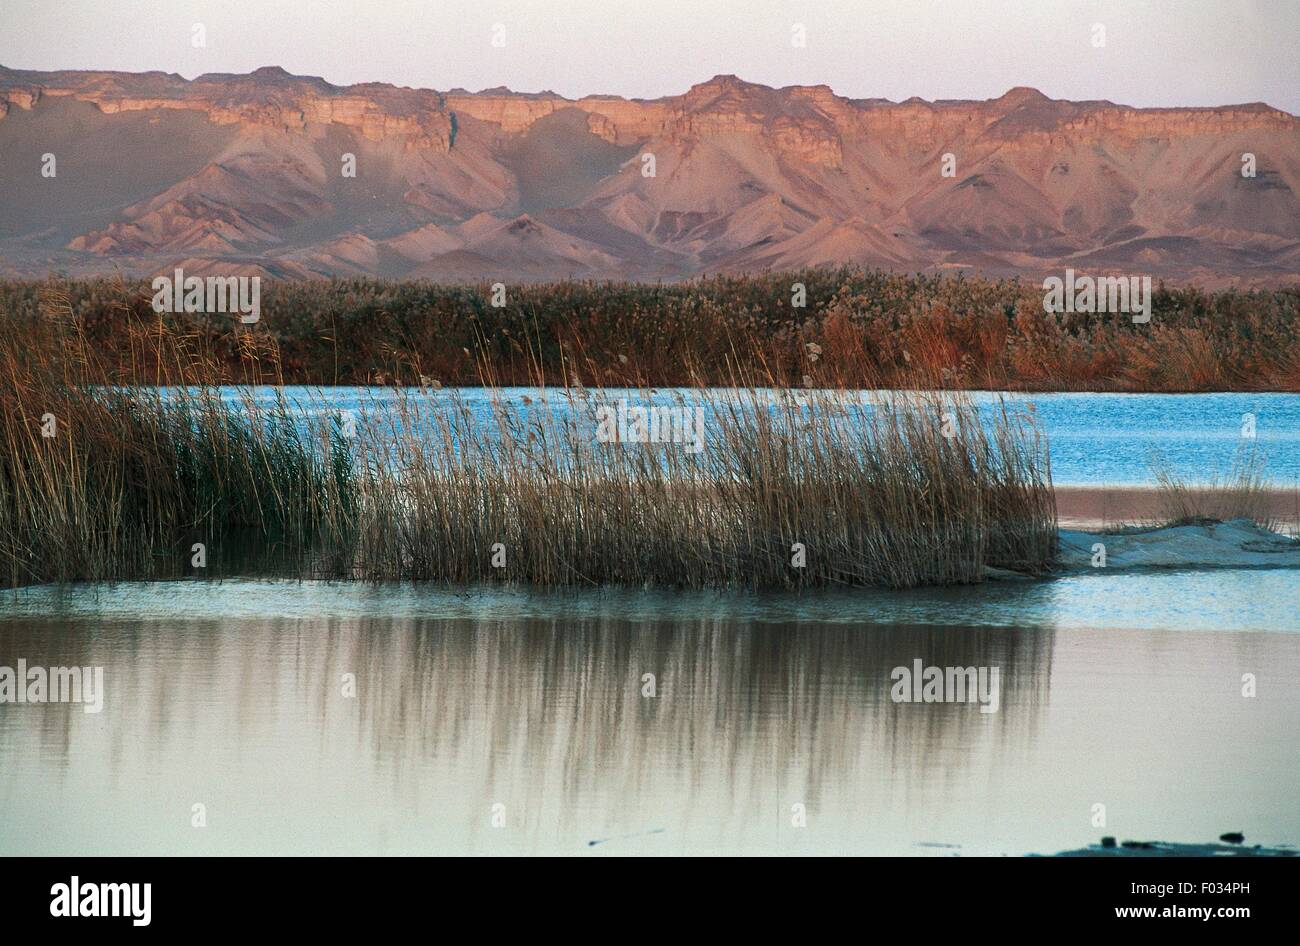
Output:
[0, 268, 1300, 391]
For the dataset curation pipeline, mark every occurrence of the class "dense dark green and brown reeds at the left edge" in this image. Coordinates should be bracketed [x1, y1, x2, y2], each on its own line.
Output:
[0, 300, 352, 586]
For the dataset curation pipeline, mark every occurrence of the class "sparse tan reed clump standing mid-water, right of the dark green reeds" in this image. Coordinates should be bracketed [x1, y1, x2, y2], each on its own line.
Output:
[340, 340, 1057, 589]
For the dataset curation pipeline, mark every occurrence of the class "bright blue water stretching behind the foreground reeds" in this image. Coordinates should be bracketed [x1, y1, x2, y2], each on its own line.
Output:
[202, 387, 1300, 486]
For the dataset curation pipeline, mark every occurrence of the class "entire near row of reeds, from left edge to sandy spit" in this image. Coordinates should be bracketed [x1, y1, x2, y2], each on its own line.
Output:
[0, 296, 1057, 589]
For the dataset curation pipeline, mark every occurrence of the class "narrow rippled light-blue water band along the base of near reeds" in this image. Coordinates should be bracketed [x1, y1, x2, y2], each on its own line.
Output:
[0, 568, 1300, 634]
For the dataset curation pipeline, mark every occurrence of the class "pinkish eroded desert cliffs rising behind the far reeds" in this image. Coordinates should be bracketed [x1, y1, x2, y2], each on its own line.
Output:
[0, 68, 1300, 282]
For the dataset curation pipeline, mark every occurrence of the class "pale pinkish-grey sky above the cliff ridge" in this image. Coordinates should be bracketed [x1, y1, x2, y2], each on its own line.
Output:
[0, 0, 1300, 114]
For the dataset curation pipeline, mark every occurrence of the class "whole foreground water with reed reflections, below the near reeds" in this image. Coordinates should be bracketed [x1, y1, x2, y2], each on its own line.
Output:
[0, 570, 1300, 855]
